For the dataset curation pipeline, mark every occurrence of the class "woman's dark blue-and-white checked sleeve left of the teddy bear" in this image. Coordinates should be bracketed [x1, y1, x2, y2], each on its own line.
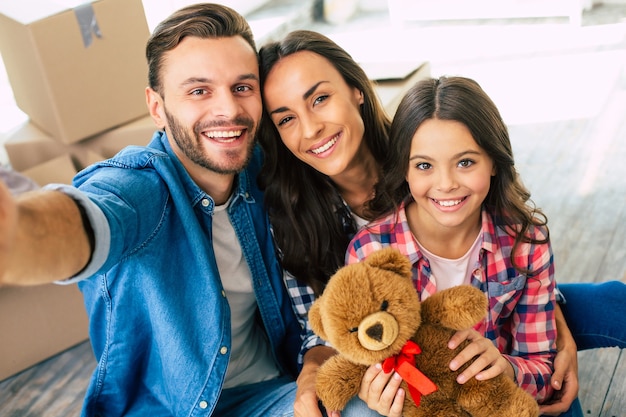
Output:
[283, 271, 330, 365]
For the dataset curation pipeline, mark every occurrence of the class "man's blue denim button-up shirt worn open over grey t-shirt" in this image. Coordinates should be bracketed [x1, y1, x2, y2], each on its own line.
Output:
[57, 132, 302, 417]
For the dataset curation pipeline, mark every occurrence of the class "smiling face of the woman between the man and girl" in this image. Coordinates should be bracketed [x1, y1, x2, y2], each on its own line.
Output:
[263, 51, 365, 177]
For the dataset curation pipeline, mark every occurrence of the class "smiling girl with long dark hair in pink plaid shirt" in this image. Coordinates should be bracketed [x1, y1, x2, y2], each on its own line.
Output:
[346, 77, 567, 415]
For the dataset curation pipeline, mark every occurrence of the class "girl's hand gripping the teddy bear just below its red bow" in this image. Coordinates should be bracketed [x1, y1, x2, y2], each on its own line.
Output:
[359, 363, 405, 417]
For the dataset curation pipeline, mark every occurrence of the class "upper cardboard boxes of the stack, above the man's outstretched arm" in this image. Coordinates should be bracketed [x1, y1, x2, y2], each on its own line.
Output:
[0, 0, 155, 185]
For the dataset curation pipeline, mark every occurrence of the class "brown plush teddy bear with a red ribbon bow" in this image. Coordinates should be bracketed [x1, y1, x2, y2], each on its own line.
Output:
[309, 248, 539, 417]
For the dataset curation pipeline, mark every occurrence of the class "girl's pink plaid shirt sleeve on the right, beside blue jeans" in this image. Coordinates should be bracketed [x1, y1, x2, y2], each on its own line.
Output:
[498, 232, 556, 403]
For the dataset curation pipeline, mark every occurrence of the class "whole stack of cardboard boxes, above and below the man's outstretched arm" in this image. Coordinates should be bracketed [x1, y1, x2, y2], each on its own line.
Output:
[0, 0, 155, 380]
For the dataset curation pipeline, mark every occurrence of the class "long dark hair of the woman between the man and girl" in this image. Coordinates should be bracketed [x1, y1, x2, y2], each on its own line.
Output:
[259, 30, 390, 294]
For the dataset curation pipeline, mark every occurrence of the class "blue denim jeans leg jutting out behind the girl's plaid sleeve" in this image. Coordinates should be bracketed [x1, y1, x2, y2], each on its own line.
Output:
[558, 281, 626, 350]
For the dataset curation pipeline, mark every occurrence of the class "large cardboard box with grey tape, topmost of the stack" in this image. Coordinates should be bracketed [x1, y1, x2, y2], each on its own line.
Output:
[0, 0, 150, 143]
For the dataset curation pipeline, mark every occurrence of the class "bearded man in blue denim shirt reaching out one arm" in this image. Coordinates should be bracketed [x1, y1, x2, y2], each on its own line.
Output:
[0, 4, 301, 417]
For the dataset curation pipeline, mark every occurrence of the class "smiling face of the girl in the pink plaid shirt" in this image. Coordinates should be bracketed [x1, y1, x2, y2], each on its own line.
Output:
[406, 119, 495, 230]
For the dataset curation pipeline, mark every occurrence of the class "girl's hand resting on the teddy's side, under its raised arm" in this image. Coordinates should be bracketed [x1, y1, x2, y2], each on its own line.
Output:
[448, 329, 515, 384]
